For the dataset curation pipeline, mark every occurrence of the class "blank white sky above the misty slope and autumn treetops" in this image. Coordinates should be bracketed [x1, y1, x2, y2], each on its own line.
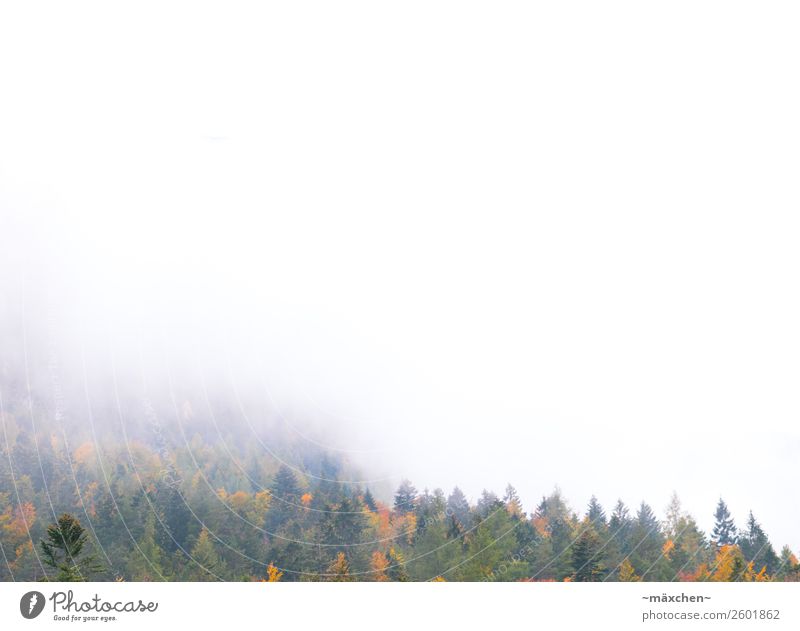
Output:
[0, 0, 800, 549]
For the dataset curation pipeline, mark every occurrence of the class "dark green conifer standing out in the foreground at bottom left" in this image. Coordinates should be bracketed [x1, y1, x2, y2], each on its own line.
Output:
[40, 513, 102, 581]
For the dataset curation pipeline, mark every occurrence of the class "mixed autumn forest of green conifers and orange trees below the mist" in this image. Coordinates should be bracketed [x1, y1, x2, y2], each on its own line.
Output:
[0, 409, 800, 581]
